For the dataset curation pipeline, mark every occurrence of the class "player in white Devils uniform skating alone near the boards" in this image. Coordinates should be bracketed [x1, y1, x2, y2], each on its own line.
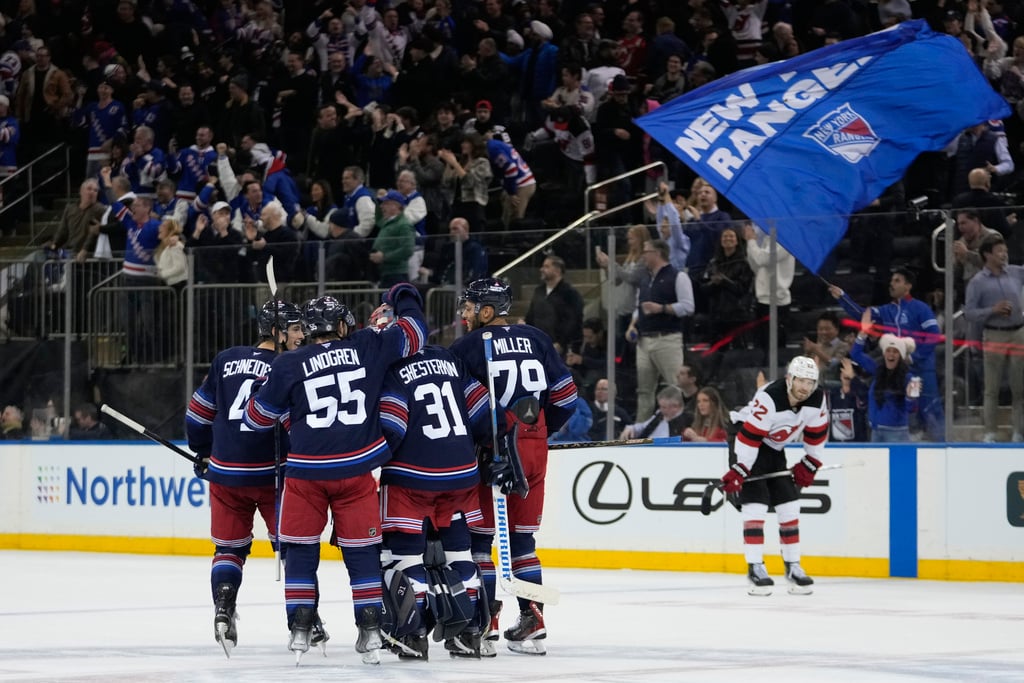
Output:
[722, 355, 828, 595]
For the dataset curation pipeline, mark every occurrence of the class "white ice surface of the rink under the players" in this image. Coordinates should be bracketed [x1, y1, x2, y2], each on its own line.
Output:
[0, 551, 1024, 683]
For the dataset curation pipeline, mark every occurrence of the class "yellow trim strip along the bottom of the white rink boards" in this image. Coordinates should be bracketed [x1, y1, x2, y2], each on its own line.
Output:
[0, 533, 1024, 583]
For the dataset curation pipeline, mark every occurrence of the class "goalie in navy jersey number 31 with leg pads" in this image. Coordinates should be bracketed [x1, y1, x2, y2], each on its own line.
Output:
[371, 305, 490, 658]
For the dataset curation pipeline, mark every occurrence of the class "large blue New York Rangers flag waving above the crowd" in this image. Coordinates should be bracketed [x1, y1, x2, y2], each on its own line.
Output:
[637, 20, 1010, 271]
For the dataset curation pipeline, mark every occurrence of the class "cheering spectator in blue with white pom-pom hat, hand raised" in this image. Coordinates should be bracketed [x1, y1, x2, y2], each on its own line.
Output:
[850, 310, 921, 443]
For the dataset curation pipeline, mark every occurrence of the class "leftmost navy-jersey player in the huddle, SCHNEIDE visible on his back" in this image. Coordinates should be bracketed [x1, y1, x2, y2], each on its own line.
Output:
[185, 301, 303, 656]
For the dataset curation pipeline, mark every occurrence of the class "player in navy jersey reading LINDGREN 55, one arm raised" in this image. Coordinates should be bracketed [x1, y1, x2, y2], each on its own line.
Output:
[245, 283, 426, 664]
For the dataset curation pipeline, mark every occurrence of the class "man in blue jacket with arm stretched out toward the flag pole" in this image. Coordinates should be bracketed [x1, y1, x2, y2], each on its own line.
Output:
[828, 264, 942, 441]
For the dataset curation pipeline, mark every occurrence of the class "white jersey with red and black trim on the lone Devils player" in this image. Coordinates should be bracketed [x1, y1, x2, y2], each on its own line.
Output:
[734, 378, 828, 468]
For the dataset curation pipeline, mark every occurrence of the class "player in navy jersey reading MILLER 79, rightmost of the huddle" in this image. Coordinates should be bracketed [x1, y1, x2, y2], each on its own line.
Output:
[452, 278, 577, 656]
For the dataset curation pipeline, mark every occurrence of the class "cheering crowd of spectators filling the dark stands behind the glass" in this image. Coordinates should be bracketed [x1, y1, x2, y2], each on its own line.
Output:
[0, 0, 1024, 444]
